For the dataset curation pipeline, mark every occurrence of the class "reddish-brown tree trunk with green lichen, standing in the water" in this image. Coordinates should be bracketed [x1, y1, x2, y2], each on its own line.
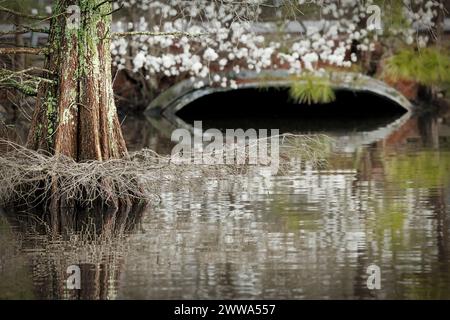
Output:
[27, 0, 127, 161]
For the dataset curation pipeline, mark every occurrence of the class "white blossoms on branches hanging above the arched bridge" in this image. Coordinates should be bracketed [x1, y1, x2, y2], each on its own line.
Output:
[112, 0, 443, 95]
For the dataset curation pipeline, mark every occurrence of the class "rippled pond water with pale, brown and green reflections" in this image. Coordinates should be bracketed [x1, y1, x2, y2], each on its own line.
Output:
[0, 110, 450, 299]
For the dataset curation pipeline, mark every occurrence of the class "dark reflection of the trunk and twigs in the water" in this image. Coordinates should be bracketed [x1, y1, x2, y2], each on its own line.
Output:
[1, 204, 145, 300]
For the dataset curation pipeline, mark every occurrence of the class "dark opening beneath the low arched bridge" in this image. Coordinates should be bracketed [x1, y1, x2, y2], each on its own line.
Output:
[176, 88, 407, 132]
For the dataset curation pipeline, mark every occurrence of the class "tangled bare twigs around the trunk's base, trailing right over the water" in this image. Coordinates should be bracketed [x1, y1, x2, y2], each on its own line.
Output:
[0, 135, 330, 206]
